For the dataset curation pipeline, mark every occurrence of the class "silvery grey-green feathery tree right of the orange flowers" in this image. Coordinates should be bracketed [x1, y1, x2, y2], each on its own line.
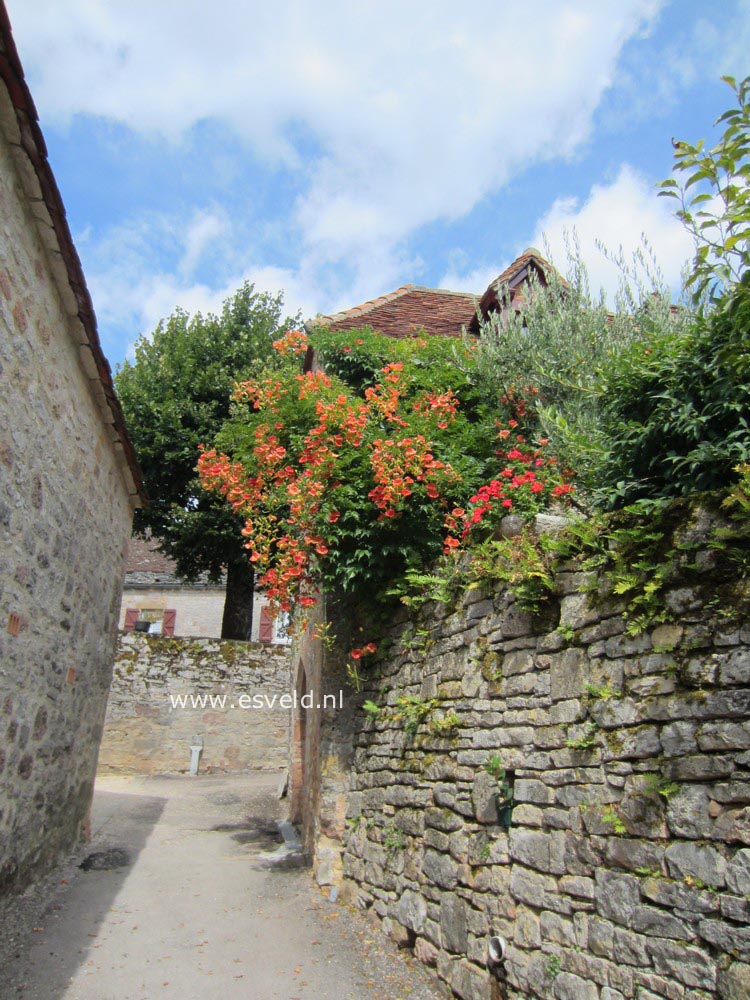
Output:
[474, 236, 683, 486]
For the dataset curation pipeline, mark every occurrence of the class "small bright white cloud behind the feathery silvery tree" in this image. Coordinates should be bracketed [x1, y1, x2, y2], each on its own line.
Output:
[519, 164, 694, 302]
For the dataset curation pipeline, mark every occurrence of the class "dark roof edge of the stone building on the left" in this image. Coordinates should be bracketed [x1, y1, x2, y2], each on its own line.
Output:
[0, 7, 146, 506]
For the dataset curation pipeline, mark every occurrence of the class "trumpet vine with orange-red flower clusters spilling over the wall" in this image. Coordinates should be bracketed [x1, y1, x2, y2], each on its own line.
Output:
[199, 331, 569, 624]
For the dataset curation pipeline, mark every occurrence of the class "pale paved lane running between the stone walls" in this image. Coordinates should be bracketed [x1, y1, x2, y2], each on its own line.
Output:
[0, 775, 445, 1000]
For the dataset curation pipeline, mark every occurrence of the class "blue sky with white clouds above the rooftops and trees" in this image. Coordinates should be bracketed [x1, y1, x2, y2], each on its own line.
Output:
[7, 0, 750, 365]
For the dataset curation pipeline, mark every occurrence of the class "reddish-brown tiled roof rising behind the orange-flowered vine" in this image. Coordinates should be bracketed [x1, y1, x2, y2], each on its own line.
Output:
[312, 285, 477, 337]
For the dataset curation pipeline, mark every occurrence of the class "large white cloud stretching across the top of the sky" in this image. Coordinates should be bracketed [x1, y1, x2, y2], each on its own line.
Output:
[10, 0, 661, 262]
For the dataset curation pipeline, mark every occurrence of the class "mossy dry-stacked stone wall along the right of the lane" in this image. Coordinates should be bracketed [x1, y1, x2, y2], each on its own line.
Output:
[306, 528, 750, 1000]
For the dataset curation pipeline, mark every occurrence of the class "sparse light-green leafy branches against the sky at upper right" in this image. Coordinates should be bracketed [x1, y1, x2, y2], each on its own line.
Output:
[659, 76, 750, 303]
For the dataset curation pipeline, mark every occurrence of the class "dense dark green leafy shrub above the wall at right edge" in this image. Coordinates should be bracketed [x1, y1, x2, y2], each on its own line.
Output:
[596, 285, 750, 507]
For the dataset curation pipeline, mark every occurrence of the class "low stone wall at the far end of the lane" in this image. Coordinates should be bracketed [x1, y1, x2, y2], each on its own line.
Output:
[99, 632, 291, 774]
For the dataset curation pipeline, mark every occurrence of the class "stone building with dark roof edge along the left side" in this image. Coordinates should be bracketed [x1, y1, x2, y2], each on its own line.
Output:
[0, 3, 142, 892]
